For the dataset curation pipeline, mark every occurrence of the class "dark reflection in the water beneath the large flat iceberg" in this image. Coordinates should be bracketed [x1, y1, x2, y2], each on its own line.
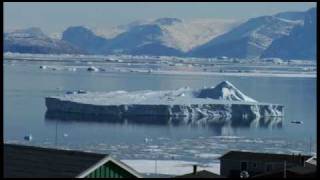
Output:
[45, 111, 283, 128]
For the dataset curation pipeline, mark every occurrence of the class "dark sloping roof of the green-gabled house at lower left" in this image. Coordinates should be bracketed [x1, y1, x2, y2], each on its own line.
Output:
[4, 144, 108, 177]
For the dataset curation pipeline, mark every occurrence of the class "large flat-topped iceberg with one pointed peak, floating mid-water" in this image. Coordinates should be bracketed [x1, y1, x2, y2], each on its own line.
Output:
[46, 81, 284, 121]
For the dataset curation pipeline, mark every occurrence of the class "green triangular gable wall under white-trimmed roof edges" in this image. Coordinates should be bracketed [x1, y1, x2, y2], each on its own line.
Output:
[86, 162, 135, 178]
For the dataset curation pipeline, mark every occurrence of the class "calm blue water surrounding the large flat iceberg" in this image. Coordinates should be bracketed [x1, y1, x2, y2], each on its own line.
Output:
[3, 62, 317, 162]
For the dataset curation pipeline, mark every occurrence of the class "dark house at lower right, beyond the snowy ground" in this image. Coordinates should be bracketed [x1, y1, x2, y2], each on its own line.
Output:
[219, 151, 311, 177]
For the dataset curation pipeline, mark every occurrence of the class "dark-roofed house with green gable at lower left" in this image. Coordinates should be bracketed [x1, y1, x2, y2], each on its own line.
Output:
[3, 144, 142, 178]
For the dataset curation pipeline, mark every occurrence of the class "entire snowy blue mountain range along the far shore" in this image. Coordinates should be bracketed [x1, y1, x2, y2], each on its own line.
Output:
[4, 8, 316, 59]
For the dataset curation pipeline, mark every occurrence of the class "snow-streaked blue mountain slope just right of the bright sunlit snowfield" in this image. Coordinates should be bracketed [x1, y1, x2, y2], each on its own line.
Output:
[189, 16, 299, 58]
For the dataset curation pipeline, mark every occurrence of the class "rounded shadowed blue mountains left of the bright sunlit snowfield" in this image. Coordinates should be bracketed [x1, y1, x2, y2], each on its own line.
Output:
[63, 19, 181, 55]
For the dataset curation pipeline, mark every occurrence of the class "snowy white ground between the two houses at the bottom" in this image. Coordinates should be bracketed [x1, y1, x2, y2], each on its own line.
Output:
[121, 160, 220, 175]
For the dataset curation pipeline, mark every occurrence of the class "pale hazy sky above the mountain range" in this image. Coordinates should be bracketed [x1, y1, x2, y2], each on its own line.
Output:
[4, 2, 316, 33]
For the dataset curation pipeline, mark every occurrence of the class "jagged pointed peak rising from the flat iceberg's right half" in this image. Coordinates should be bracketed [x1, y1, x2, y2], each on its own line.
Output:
[196, 81, 257, 102]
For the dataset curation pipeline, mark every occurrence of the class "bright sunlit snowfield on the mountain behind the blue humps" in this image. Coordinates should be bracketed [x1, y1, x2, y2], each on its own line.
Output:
[93, 18, 240, 52]
